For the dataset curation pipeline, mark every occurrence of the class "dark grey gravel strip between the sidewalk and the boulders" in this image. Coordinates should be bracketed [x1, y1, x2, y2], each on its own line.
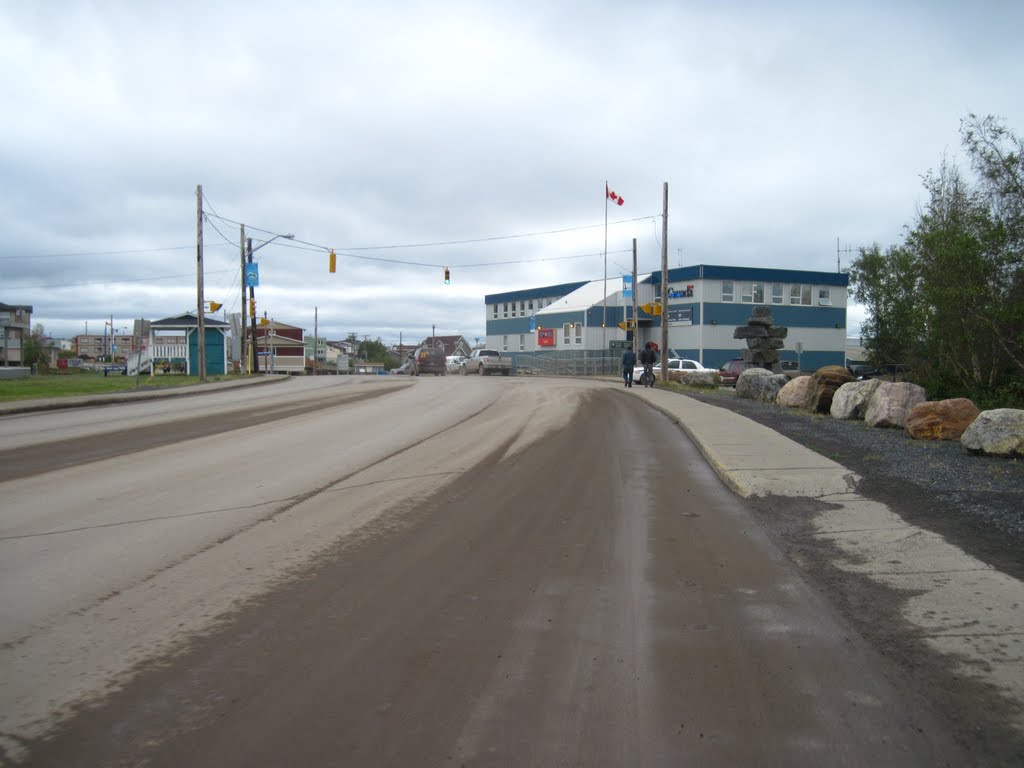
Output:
[681, 388, 1024, 581]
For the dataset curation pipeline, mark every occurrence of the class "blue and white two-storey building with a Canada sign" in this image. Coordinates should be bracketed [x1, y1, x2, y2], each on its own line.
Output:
[483, 264, 849, 370]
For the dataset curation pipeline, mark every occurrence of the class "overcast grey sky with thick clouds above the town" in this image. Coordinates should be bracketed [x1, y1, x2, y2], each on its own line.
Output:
[0, 0, 1024, 343]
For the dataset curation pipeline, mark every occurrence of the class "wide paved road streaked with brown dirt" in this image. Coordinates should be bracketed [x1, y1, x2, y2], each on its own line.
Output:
[0, 377, 967, 766]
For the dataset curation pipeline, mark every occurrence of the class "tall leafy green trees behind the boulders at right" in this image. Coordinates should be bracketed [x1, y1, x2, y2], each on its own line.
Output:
[850, 115, 1024, 404]
